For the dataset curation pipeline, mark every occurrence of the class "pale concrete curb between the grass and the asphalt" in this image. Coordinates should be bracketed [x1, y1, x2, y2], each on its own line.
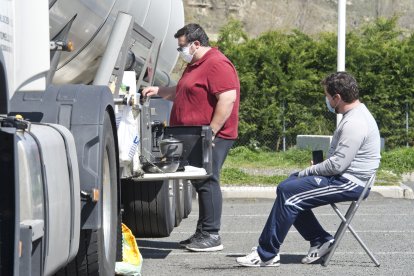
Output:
[221, 184, 414, 199]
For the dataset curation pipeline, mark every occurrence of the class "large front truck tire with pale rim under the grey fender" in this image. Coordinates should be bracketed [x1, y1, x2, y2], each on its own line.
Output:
[56, 112, 119, 276]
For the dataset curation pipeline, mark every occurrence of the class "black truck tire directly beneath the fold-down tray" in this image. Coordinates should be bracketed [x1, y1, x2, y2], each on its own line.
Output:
[121, 179, 175, 238]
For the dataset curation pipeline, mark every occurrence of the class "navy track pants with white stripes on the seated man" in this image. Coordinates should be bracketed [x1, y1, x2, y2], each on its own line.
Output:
[257, 173, 364, 261]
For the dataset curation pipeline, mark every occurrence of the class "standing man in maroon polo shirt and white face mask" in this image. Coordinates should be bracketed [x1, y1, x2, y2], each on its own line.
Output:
[142, 24, 240, 252]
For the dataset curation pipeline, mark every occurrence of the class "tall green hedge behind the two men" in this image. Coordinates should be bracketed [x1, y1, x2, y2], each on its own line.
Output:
[217, 17, 414, 149]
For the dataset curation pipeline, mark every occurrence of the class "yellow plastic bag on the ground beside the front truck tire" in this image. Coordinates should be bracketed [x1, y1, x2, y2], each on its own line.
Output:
[115, 223, 143, 276]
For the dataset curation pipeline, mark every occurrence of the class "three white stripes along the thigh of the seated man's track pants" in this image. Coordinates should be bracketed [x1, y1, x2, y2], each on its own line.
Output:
[285, 181, 358, 210]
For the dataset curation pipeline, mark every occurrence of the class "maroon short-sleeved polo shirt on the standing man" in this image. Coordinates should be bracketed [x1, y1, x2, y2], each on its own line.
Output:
[170, 48, 240, 139]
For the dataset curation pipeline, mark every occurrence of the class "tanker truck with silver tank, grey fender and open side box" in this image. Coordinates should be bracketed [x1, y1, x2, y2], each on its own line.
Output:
[0, 0, 212, 275]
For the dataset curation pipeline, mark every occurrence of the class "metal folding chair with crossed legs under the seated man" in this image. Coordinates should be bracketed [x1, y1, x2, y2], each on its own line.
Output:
[322, 174, 380, 266]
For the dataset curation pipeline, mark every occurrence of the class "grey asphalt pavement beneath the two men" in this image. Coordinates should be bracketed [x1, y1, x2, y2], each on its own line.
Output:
[138, 192, 414, 276]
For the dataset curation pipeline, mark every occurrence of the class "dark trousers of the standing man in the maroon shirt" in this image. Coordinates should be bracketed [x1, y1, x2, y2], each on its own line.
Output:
[193, 137, 234, 234]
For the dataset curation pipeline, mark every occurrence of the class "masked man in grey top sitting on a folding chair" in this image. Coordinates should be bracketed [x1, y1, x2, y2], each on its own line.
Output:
[237, 72, 381, 266]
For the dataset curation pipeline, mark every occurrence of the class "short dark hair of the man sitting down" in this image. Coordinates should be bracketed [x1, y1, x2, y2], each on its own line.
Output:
[321, 72, 359, 103]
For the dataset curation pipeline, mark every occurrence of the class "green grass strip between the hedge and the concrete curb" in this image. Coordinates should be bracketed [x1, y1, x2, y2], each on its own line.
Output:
[221, 147, 414, 186]
